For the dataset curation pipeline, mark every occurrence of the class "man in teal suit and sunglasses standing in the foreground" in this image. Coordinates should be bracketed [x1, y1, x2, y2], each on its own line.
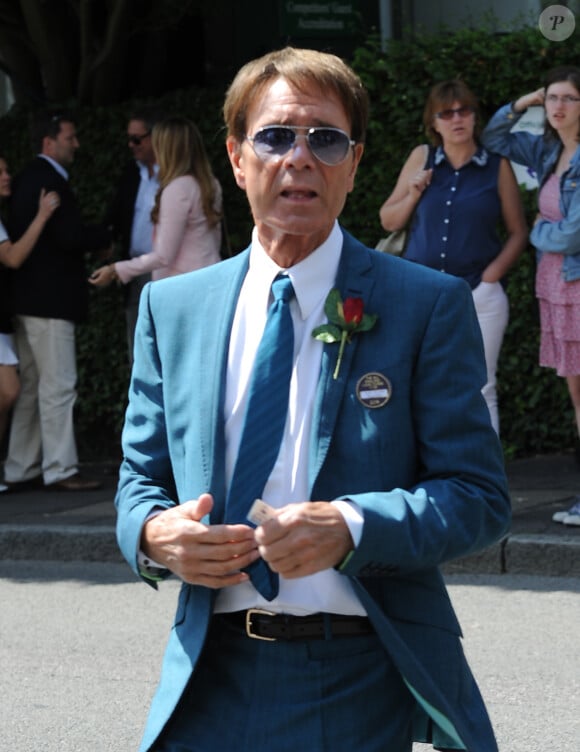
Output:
[116, 48, 510, 752]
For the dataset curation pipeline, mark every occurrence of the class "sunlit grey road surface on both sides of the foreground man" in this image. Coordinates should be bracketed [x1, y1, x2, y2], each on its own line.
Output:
[0, 561, 580, 752]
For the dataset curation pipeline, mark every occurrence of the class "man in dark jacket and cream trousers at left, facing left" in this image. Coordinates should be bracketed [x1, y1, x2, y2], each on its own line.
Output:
[4, 108, 110, 491]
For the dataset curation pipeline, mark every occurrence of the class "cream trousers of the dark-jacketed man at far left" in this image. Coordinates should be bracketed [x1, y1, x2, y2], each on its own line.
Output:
[4, 316, 78, 483]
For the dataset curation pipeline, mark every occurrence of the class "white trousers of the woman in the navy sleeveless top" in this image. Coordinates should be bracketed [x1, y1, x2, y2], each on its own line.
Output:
[473, 282, 509, 435]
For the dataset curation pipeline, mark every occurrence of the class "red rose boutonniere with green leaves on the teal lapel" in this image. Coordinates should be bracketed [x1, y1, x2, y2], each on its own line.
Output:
[312, 289, 378, 379]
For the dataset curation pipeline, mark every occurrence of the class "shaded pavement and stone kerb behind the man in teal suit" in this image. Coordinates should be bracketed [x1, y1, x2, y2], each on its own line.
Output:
[0, 454, 580, 577]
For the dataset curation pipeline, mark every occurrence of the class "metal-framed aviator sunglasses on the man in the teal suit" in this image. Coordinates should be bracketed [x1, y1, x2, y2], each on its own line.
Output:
[246, 125, 356, 167]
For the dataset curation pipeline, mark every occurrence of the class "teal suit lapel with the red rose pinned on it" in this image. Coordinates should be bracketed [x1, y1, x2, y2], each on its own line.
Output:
[308, 230, 374, 490]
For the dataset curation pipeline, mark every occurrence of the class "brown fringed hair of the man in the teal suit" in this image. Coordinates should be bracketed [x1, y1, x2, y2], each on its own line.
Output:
[223, 47, 369, 143]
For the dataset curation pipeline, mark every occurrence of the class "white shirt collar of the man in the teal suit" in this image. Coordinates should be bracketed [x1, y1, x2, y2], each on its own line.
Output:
[248, 221, 343, 320]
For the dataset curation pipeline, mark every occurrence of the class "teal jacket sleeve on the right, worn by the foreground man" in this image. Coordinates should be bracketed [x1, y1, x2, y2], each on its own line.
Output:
[340, 280, 510, 577]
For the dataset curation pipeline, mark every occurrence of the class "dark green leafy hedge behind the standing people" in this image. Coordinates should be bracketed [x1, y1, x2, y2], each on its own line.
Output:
[0, 28, 580, 459]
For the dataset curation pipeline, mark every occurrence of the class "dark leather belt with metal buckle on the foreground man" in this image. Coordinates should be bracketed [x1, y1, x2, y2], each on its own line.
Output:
[215, 608, 374, 641]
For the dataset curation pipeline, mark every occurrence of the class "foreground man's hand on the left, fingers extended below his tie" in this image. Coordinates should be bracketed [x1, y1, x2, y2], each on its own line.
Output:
[141, 494, 260, 588]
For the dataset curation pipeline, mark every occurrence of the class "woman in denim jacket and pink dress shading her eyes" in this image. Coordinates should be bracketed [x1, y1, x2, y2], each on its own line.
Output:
[483, 66, 580, 525]
